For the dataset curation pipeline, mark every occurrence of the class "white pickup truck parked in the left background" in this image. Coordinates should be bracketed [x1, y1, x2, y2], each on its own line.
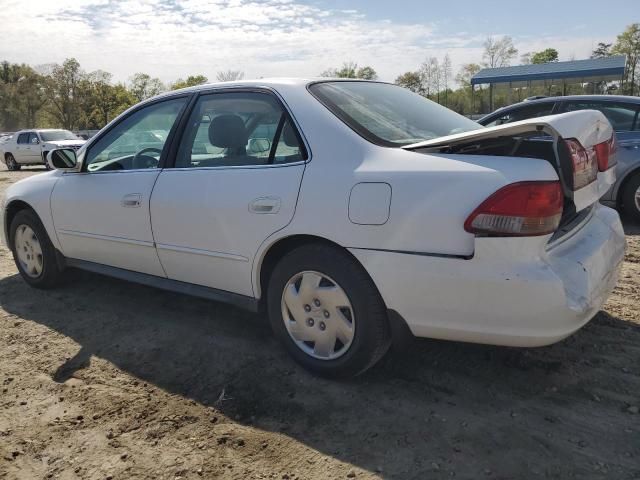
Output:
[2, 129, 85, 170]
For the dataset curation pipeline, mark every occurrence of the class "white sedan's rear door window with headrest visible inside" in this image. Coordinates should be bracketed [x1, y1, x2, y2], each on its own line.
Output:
[176, 92, 306, 168]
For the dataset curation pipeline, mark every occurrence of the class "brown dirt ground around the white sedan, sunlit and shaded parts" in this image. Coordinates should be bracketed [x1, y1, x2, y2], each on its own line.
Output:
[0, 169, 640, 480]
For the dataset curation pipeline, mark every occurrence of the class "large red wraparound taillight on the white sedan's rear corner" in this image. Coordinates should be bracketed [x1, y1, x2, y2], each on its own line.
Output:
[464, 182, 563, 237]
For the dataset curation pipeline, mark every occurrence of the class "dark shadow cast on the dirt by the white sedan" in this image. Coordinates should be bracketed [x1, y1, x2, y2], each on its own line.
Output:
[0, 264, 640, 478]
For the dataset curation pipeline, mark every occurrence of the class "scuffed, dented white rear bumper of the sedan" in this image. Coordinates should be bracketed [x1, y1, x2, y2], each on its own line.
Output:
[351, 207, 624, 346]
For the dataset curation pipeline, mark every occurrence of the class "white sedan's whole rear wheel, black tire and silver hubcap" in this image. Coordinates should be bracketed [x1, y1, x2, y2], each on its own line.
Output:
[267, 244, 391, 377]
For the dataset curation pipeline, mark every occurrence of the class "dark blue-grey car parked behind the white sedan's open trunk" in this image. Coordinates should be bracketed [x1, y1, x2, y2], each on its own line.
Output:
[478, 95, 640, 220]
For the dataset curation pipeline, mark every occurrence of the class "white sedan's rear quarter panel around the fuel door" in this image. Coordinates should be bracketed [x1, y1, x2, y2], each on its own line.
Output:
[253, 85, 558, 297]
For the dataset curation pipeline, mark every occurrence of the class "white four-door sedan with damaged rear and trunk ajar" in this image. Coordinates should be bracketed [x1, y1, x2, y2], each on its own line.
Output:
[0, 79, 625, 376]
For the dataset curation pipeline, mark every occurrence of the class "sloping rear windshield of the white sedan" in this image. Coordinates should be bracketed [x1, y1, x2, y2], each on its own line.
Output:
[309, 81, 483, 147]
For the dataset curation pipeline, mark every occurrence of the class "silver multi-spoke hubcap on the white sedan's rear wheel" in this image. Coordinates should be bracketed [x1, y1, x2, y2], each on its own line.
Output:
[282, 271, 355, 360]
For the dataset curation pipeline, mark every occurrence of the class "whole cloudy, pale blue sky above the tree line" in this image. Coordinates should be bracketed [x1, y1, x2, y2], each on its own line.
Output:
[0, 0, 640, 82]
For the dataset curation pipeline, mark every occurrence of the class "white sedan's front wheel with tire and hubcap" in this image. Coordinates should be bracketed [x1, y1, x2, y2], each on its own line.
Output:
[9, 210, 62, 288]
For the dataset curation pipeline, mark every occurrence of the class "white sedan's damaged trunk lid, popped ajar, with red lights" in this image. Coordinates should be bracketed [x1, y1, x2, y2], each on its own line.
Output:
[402, 110, 616, 211]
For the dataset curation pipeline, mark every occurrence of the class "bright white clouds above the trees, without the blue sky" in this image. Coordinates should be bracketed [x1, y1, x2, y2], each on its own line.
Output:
[0, 0, 608, 81]
